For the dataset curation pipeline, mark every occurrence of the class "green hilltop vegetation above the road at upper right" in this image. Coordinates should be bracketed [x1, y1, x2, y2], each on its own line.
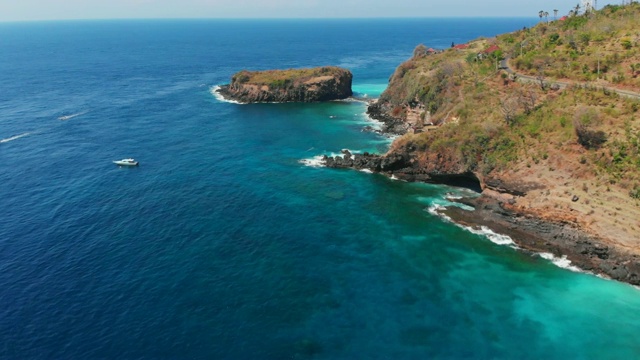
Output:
[512, 3, 640, 88]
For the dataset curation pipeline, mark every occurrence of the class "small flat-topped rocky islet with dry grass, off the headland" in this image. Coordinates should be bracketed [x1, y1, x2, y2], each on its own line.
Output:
[218, 66, 353, 103]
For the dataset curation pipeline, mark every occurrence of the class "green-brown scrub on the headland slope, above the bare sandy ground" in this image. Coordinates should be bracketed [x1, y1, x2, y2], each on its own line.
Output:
[380, 4, 640, 190]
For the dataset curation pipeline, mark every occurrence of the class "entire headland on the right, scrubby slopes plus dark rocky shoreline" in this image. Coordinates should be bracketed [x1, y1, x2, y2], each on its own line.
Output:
[324, 3, 640, 285]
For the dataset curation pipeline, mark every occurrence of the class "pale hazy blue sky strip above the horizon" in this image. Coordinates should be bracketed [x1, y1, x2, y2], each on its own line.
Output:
[0, 0, 621, 21]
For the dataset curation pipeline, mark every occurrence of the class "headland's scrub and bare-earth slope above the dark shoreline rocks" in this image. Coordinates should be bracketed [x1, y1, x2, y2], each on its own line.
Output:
[377, 4, 640, 246]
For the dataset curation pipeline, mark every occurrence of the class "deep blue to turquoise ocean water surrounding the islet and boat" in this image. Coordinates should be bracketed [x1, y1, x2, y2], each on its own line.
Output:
[0, 19, 640, 359]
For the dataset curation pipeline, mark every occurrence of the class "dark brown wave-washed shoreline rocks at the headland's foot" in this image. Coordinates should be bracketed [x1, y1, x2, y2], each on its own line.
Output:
[323, 103, 640, 285]
